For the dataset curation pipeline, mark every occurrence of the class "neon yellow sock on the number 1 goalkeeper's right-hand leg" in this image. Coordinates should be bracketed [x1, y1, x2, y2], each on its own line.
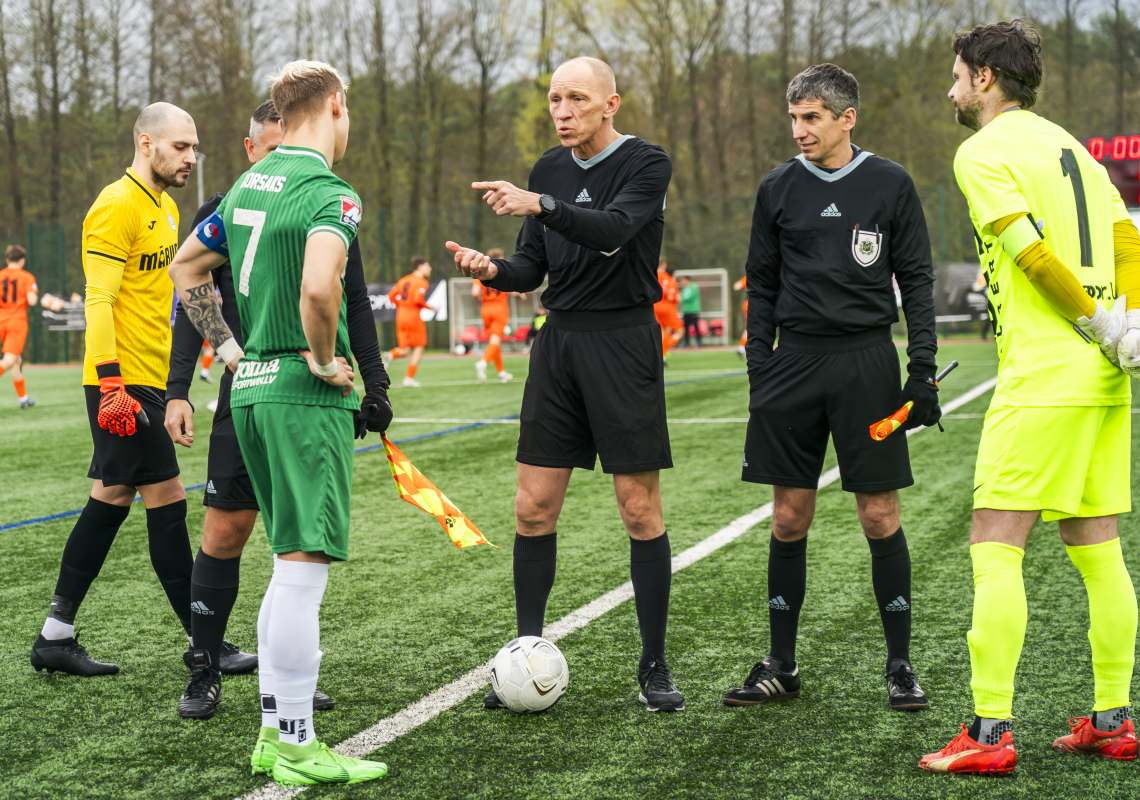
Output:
[1065, 539, 1137, 711]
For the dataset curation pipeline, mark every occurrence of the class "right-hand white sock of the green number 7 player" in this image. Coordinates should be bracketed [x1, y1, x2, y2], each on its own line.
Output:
[269, 558, 328, 744]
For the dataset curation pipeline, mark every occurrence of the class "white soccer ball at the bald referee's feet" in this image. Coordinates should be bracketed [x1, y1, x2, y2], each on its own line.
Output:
[491, 636, 570, 713]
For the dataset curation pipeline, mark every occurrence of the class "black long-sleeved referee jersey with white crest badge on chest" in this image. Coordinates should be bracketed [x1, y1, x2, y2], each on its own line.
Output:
[746, 145, 937, 376]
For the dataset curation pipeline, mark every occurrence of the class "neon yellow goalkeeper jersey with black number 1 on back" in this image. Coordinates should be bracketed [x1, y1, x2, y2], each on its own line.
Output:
[954, 111, 1132, 407]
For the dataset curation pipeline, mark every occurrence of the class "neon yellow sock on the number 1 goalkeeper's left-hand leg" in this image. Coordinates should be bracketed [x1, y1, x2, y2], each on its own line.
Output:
[966, 541, 1029, 719]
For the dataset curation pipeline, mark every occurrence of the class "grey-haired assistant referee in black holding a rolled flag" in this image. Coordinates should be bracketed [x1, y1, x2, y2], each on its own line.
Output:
[724, 64, 942, 710]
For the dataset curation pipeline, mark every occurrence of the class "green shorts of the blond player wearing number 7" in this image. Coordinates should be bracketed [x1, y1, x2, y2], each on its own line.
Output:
[234, 402, 353, 561]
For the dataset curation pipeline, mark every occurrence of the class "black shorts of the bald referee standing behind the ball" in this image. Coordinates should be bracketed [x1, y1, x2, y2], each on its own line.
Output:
[518, 308, 673, 474]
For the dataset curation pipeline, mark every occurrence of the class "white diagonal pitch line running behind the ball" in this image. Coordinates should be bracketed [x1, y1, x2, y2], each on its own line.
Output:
[238, 377, 998, 800]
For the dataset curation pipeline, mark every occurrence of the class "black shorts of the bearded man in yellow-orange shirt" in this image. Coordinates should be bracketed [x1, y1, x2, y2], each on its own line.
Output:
[83, 385, 178, 487]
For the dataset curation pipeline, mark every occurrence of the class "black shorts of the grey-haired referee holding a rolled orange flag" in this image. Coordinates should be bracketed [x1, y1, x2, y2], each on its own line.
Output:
[741, 334, 914, 492]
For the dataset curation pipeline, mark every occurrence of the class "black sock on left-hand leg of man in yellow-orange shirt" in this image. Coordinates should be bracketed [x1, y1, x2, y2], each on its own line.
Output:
[51, 497, 131, 625]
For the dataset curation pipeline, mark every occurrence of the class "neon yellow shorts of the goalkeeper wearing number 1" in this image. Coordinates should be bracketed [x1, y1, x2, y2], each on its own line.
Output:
[974, 406, 1132, 520]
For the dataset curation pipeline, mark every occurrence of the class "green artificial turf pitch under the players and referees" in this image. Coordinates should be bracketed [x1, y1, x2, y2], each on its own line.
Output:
[0, 344, 1140, 800]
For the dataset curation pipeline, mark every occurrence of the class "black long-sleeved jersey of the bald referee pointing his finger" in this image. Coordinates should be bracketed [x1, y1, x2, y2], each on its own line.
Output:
[486, 136, 673, 312]
